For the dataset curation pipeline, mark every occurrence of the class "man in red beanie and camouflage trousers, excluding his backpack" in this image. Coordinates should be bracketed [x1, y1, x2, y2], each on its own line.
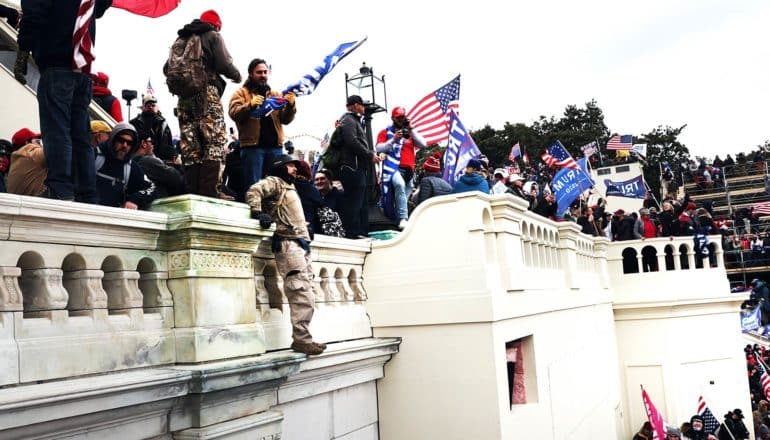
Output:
[163, 10, 241, 200]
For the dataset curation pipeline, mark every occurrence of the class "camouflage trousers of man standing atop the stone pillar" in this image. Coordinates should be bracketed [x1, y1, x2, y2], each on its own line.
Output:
[177, 84, 227, 166]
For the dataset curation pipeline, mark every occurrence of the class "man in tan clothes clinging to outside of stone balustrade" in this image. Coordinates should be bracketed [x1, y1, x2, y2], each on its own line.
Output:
[246, 154, 326, 355]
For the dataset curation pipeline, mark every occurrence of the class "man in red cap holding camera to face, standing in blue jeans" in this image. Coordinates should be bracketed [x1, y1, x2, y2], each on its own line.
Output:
[375, 107, 425, 229]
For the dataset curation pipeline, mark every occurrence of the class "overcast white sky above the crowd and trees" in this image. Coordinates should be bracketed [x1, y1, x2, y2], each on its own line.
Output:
[76, 0, 770, 161]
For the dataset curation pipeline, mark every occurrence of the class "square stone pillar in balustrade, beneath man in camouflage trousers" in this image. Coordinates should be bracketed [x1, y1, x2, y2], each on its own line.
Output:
[151, 194, 271, 363]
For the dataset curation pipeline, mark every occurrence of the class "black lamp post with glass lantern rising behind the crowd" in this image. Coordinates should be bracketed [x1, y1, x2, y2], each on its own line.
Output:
[345, 63, 397, 231]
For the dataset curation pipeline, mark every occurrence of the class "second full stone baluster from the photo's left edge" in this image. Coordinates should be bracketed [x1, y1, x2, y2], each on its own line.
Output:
[62, 269, 108, 318]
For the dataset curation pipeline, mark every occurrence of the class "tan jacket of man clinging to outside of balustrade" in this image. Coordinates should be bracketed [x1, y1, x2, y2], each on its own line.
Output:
[246, 176, 310, 241]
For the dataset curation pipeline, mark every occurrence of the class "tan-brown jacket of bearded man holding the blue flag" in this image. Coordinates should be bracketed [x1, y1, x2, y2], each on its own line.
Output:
[228, 87, 297, 148]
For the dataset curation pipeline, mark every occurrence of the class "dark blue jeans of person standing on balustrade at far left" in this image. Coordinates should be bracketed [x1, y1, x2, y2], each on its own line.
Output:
[37, 68, 97, 203]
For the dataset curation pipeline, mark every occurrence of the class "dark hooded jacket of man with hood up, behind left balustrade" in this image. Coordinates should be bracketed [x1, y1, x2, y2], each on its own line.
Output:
[96, 122, 155, 209]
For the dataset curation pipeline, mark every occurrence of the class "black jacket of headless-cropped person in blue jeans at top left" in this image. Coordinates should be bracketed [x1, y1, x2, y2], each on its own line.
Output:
[18, 0, 112, 73]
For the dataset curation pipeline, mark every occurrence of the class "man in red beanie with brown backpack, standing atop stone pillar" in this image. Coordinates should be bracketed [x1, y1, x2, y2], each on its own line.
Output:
[163, 10, 241, 200]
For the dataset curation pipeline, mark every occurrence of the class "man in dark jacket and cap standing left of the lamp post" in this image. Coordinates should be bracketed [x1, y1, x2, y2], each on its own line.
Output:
[339, 95, 380, 238]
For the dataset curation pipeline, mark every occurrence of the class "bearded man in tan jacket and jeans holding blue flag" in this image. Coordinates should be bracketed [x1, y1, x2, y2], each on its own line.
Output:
[229, 58, 297, 188]
